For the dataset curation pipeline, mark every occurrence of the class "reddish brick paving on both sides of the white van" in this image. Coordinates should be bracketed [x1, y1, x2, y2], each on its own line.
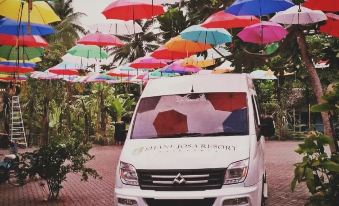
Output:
[0, 142, 307, 206]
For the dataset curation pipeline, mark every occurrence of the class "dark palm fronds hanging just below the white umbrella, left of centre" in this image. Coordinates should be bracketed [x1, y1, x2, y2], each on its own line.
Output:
[111, 20, 159, 64]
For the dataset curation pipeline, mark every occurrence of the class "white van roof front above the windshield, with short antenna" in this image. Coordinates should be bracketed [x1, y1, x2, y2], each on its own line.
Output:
[141, 74, 254, 98]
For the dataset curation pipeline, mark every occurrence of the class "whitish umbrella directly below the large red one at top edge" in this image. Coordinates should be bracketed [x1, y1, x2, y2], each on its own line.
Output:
[89, 20, 143, 36]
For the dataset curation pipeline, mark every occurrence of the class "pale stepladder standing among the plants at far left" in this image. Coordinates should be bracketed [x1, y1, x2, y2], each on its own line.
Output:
[10, 96, 27, 147]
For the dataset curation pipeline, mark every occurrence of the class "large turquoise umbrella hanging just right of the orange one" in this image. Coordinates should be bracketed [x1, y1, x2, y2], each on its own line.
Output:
[180, 25, 232, 45]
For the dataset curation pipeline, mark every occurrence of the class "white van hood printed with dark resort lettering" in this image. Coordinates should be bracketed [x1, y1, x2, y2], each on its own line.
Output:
[120, 136, 250, 170]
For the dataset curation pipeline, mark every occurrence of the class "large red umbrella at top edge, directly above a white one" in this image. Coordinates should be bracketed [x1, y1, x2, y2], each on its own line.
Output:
[102, 0, 164, 21]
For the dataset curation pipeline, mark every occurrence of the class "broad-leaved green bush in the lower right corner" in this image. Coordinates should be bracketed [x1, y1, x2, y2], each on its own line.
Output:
[291, 132, 339, 206]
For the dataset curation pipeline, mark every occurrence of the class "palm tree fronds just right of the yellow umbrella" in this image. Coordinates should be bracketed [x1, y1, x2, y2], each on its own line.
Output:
[50, 0, 86, 49]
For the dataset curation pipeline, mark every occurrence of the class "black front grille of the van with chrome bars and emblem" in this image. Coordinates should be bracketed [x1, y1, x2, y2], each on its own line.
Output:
[137, 168, 226, 191]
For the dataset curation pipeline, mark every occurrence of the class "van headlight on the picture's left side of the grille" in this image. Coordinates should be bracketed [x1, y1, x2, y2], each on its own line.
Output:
[119, 162, 139, 186]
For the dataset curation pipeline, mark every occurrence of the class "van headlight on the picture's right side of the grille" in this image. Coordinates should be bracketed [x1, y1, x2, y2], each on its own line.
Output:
[224, 159, 249, 185]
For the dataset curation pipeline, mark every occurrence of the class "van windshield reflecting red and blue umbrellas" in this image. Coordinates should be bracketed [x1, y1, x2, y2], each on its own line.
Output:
[131, 93, 248, 139]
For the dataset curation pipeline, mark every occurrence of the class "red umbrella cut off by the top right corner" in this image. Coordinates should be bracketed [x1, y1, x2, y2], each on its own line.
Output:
[303, 0, 339, 12]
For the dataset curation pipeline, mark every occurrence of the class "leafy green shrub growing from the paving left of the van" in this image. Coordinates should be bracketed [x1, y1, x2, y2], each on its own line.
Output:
[20, 136, 101, 200]
